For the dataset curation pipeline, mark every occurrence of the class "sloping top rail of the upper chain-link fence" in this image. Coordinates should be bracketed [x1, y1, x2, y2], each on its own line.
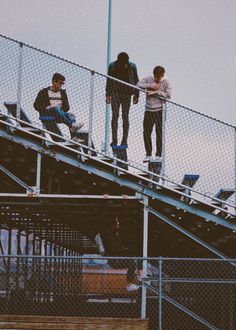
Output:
[0, 34, 236, 129]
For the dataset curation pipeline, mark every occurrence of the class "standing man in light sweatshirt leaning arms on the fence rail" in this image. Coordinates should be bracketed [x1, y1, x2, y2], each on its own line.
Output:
[137, 66, 171, 162]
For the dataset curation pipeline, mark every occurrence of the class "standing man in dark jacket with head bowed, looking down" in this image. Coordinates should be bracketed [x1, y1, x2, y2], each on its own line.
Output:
[106, 53, 139, 146]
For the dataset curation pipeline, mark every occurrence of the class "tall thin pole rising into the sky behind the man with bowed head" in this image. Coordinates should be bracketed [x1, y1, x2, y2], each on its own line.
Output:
[104, 0, 112, 155]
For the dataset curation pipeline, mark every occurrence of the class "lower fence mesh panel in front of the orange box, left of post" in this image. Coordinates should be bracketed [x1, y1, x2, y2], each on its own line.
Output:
[0, 255, 141, 318]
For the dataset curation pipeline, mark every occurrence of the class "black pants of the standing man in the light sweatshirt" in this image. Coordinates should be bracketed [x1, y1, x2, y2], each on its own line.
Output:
[143, 110, 162, 157]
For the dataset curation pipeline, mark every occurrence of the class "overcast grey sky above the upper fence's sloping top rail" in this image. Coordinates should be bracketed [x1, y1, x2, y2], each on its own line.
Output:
[0, 0, 236, 125]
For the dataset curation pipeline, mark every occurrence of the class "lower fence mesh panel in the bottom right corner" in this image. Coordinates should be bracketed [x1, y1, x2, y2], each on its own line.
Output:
[162, 259, 236, 329]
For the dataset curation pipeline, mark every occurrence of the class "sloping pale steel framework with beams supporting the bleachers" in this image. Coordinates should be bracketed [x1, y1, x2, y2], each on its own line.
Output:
[0, 115, 236, 257]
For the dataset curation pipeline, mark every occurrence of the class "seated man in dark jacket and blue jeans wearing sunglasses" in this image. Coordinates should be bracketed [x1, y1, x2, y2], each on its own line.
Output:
[34, 73, 84, 142]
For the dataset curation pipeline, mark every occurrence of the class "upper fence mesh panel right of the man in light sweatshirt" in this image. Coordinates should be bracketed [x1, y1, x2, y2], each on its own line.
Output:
[166, 102, 235, 200]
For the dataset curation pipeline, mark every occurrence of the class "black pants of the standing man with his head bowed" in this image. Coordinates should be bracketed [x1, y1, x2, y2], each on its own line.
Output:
[111, 95, 131, 144]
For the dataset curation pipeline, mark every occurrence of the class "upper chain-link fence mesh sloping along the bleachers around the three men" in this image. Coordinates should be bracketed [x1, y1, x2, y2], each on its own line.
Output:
[0, 36, 236, 205]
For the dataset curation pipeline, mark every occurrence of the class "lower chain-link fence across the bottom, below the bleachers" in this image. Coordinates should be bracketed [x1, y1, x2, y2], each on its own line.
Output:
[0, 255, 236, 330]
